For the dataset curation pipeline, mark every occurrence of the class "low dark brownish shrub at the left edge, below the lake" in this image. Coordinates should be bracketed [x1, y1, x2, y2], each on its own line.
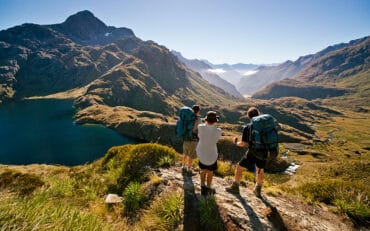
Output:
[0, 170, 44, 196]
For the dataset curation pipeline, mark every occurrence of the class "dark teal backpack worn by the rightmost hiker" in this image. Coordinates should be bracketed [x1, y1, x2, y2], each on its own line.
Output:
[250, 114, 279, 160]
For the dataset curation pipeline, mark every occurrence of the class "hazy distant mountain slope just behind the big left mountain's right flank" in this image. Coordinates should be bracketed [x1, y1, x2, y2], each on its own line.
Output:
[171, 51, 242, 97]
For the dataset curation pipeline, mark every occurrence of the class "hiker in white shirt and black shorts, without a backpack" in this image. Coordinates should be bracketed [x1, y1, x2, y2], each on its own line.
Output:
[196, 111, 222, 195]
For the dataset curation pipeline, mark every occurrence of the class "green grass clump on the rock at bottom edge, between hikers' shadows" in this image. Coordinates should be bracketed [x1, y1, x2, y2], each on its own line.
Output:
[199, 196, 226, 231]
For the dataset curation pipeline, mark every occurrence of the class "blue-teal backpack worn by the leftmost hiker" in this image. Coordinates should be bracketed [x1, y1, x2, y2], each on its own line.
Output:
[176, 106, 195, 140]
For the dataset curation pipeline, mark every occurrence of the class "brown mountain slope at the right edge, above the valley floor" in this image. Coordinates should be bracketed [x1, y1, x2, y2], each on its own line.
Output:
[253, 37, 370, 99]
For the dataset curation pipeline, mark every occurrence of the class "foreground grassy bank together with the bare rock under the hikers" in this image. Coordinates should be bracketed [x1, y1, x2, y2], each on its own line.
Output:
[0, 144, 362, 230]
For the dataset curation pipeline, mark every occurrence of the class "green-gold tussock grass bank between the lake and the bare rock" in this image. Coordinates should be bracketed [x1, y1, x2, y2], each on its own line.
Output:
[0, 144, 183, 230]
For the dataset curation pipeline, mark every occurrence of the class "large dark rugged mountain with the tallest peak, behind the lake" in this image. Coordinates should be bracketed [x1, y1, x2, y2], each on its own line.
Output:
[0, 11, 233, 115]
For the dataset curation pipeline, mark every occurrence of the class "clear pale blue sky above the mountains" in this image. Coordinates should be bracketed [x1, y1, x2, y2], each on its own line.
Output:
[0, 0, 370, 64]
